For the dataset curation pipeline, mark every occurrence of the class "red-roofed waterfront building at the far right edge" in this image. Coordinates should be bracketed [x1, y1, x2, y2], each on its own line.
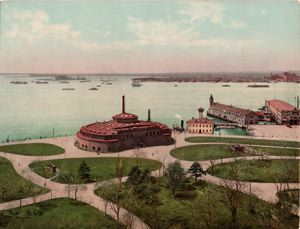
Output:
[265, 99, 300, 125]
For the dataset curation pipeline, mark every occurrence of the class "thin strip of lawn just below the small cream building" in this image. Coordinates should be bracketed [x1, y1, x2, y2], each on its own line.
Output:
[185, 137, 300, 147]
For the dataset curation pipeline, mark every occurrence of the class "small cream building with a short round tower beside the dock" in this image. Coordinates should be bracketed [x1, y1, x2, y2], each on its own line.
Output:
[186, 107, 214, 134]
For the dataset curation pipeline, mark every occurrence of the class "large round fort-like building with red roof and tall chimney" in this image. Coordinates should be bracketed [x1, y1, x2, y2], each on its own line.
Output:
[75, 96, 172, 152]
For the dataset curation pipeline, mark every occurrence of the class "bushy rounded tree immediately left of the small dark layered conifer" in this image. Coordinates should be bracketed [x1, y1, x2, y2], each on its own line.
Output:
[165, 161, 186, 196]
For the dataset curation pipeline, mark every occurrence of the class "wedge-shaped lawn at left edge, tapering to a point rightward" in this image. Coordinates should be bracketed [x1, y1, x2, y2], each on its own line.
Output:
[0, 157, 49, 203]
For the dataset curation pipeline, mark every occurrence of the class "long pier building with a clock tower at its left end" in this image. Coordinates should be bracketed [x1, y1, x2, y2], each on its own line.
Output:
[207, 95, 258, 125]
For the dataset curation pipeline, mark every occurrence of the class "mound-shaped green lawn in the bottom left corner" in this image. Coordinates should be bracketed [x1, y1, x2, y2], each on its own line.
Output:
[0, 198, 125, 229]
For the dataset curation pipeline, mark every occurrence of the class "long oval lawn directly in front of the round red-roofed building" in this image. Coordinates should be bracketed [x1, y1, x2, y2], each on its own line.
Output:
[29, 157, 161, 183]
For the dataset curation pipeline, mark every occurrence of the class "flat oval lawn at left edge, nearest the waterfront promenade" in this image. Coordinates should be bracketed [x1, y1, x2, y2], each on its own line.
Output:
[0, 143, 65, 156]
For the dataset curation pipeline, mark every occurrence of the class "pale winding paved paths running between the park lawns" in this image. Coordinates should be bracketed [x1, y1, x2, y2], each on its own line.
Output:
[0, 134, 300, 228]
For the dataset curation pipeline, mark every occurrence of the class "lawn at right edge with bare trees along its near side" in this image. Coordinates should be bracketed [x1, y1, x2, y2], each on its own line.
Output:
[207, 160, 299, 183]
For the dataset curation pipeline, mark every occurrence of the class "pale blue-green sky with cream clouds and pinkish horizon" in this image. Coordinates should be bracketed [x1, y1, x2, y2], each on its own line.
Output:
[0, 0, 300, 73]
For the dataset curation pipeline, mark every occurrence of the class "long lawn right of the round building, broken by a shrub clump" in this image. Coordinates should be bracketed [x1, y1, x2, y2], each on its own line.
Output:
[170, 144, 300, 161]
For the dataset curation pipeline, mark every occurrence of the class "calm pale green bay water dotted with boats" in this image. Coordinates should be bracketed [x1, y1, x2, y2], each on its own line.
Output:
[0, 76, 300, 141]
